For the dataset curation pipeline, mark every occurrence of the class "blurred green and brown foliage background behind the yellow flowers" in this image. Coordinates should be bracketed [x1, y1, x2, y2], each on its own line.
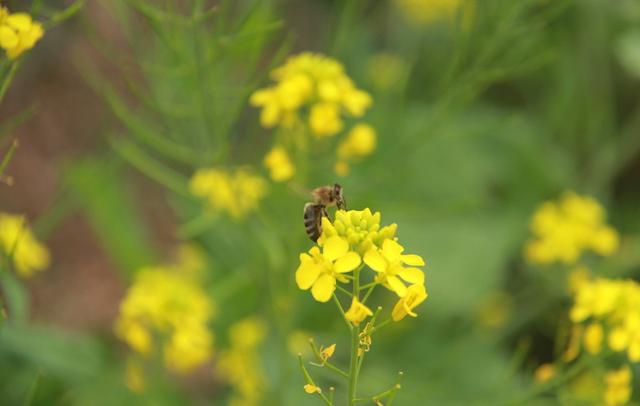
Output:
[0, 0, 640, 405]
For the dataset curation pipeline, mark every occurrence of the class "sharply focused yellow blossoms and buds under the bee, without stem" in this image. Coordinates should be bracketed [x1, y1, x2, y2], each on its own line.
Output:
[296, 209, 427, 324]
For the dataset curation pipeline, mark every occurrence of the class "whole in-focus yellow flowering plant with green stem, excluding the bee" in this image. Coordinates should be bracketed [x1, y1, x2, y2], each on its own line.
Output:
[295, 208, 428, 404]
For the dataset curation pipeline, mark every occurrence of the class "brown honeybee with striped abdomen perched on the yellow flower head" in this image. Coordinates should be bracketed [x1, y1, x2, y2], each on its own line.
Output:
[304, 183, 347, 242]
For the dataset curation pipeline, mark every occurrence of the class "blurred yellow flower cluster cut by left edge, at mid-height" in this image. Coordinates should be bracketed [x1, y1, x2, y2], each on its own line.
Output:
[0, 213, 50, 278]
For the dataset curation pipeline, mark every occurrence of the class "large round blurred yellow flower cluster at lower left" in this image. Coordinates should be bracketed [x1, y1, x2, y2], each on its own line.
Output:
[115, 266, 214, 372]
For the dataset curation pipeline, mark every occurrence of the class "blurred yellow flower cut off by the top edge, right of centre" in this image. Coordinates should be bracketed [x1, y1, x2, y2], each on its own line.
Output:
[395, 0, 473, 25]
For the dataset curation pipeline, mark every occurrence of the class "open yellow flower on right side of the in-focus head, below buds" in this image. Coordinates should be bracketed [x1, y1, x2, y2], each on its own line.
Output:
[364, 240, 425, 296]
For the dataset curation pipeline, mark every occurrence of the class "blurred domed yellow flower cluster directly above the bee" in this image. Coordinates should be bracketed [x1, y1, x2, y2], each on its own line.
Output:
[250, 52, 372, 137]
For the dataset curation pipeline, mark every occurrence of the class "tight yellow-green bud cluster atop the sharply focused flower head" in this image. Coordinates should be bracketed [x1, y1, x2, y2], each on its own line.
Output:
[318, 208, 398, 256]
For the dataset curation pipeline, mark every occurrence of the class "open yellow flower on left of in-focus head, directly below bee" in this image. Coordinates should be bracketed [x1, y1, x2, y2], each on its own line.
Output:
[296, 236, 361, 302]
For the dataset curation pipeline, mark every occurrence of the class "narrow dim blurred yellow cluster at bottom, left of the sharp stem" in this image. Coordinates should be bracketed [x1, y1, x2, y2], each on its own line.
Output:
[217, 317, 266, 406]
